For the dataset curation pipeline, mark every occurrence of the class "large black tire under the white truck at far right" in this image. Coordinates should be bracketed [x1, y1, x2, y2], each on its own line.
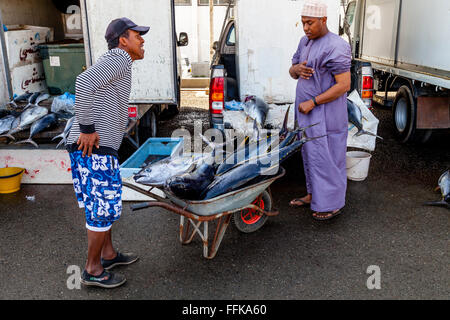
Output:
[392, 86, 432, 143]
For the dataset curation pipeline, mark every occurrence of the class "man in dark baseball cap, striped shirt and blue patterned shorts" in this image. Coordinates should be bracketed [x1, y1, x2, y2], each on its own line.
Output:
[66, 18, 150, 288]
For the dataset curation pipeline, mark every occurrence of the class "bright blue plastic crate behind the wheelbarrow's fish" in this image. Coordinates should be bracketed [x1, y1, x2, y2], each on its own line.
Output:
[120, 138, 183, 178]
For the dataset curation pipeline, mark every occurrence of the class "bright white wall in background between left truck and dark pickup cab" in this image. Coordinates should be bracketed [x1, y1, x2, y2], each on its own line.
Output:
[175, 0, 227, 62]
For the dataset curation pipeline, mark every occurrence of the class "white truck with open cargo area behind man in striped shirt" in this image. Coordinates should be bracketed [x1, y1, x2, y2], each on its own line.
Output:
[0, 0, 188, 145]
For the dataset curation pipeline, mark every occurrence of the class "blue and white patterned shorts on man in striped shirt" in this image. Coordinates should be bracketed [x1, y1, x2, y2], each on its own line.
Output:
[70, 151, 122, 232]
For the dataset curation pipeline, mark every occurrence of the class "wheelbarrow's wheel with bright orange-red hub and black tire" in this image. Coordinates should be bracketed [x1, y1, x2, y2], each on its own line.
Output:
[232, 191, 272, 233]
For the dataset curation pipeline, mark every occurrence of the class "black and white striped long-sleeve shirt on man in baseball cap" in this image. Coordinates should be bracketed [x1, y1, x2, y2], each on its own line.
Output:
[66, 48, 133, 157]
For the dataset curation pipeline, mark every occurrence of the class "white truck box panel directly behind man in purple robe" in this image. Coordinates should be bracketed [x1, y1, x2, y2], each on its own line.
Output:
[235, 0, 339, 103]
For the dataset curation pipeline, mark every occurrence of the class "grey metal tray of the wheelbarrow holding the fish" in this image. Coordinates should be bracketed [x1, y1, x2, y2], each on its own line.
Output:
[164, 167, 285, 216]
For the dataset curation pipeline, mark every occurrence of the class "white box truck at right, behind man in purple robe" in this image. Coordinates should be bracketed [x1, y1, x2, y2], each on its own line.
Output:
[340, 0, 450, 143]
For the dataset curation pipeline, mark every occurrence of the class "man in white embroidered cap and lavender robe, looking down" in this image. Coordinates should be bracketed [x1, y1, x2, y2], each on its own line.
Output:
[289, 0, 352, 220]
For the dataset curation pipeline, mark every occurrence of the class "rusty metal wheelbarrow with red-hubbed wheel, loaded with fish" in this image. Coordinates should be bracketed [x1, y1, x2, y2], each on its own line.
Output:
[123, 167, 285, 259]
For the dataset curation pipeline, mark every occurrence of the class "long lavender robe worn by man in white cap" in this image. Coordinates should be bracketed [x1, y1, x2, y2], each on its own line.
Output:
[292, 32, 352, 212]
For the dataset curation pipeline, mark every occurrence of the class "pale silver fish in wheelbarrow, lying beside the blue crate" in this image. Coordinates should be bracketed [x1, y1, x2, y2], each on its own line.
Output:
[134, 155, 203, 187]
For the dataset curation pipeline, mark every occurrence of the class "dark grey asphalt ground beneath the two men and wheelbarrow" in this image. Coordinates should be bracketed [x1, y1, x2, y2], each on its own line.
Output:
[0, 94, 450, 301]
